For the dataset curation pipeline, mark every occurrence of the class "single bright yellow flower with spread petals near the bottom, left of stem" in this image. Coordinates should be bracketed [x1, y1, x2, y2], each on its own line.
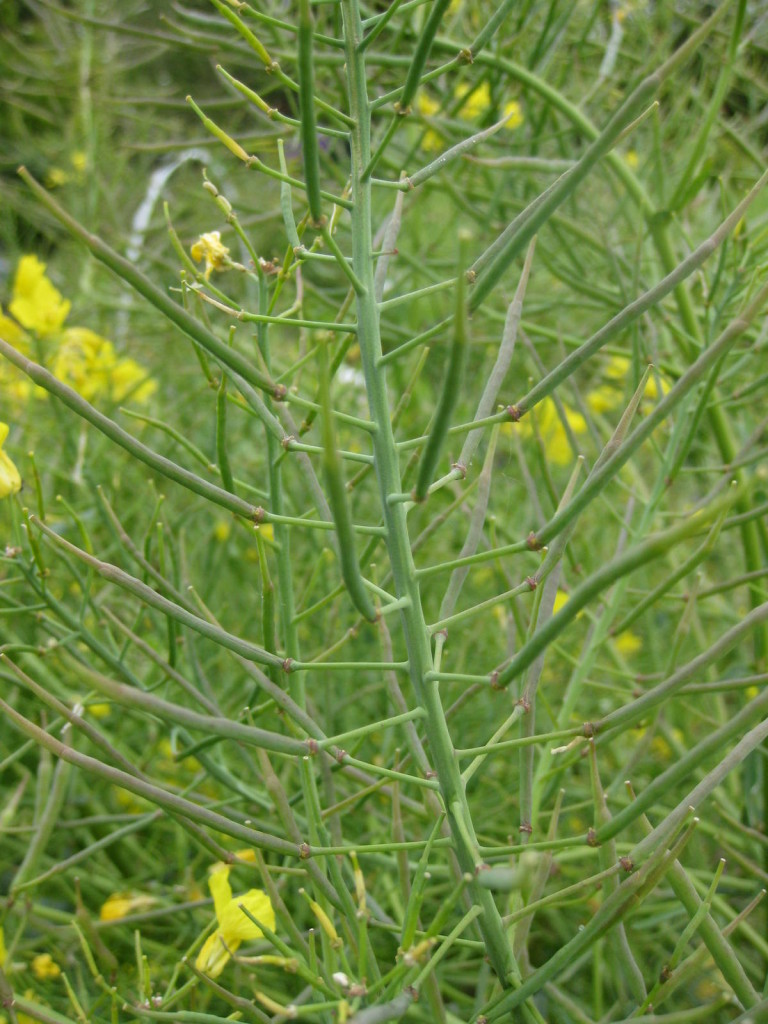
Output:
[195, 864, 274, 978]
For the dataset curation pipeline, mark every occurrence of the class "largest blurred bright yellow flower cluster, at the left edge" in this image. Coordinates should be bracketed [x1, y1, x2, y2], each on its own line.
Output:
[0, 255, 157, 402]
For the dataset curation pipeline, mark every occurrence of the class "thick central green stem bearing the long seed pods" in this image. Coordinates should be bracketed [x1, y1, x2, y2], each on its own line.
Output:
[341, 0, 520, 986]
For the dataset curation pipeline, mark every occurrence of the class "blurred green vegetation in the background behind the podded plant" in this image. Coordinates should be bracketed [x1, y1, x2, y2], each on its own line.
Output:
[0, 0, 768, 1021]
